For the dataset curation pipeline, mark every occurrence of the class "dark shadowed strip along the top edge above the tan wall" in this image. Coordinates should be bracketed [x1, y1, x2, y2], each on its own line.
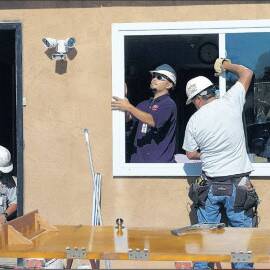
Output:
[0, 0, 269, 9]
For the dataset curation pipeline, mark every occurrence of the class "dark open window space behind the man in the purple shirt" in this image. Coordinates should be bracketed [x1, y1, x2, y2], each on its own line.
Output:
[125, 34, 219, 162]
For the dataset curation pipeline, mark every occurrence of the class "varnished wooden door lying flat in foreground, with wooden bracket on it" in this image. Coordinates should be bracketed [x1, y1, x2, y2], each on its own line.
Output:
[0, 212, 270, 263]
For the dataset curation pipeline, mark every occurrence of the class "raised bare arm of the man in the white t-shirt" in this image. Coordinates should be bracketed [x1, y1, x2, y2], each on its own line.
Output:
[222, 61, 253, 92]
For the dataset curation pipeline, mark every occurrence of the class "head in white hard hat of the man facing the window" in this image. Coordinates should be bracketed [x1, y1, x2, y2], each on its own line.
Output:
[186, 76, 216, 110]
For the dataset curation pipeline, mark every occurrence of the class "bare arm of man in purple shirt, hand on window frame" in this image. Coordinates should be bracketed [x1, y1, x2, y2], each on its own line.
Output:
[111, 97, 155, 127]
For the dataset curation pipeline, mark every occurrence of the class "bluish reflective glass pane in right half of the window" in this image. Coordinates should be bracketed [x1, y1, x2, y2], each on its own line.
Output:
[226, 33, 270, 163]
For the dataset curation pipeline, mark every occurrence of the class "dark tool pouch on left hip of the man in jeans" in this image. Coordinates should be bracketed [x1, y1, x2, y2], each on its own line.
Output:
[188, 183, 210, 207]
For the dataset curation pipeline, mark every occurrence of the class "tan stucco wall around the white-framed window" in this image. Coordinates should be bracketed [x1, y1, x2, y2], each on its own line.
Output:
[0, 1, 270, 268]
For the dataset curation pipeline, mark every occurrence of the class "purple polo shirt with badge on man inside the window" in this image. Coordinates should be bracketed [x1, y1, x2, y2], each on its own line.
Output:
[130, 94, 177, 163]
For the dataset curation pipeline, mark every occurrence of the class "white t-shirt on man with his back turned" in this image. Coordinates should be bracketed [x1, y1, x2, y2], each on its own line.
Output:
[183, 82, 253, 177]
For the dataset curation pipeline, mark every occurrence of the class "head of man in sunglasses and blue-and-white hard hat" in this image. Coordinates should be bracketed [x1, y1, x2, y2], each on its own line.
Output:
[150, 64, 176, 92]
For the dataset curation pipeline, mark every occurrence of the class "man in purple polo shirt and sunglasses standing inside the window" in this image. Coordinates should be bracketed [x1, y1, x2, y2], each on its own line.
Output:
[111, 64, 177, 163]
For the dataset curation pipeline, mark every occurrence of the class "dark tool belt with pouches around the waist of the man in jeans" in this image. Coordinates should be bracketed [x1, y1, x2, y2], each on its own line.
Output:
[188, 173, 259, 227]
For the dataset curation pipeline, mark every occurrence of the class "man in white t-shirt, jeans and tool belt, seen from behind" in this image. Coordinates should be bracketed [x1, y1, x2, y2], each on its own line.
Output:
[183, 58, 258, 270]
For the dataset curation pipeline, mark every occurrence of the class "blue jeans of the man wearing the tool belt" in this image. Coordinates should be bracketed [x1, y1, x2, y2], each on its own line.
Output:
[193, 185, 253, 270]
